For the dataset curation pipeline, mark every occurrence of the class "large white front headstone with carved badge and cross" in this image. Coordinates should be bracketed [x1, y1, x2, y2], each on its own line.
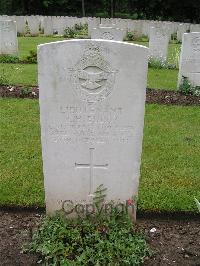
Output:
[38, 40, 148, 218]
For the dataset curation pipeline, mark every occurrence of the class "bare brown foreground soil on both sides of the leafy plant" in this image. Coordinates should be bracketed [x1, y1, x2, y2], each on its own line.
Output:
[0, 209, 200, 266]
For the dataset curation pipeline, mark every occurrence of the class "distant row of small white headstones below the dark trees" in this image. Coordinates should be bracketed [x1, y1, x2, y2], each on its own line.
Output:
[0, 16, 200, 41]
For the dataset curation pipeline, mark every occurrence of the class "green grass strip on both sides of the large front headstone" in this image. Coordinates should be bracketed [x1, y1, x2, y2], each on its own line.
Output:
[0, 99, 200, 211]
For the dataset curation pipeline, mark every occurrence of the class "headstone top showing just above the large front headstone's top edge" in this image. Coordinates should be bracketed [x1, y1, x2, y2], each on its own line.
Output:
[91, 27, 126, 41]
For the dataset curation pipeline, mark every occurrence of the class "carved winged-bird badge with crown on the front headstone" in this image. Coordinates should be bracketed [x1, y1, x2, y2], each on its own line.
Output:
[71, 43, 117, 103]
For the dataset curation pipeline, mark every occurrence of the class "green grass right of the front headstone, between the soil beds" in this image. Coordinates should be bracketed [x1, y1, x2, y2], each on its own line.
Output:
[139, 105, 200, 211]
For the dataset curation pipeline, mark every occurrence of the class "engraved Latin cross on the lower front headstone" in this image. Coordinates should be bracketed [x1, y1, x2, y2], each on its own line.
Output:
[75, 148, 108, 195]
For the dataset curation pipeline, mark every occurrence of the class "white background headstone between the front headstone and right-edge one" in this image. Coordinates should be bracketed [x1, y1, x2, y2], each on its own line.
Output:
[149, 27, 169, 61]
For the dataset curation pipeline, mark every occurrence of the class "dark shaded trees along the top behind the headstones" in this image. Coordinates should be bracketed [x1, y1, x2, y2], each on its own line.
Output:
[0, 0, 200, 23]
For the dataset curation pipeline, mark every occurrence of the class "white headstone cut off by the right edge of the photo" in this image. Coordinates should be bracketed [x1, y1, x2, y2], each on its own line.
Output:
[178, 32, 200, 87]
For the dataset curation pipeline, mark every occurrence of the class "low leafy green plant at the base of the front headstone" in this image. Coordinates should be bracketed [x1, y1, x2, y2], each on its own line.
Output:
[23, 208, 151, 266]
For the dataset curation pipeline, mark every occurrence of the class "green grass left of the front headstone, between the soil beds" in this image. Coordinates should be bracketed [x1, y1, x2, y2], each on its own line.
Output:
[0, 99, 44, 206]
